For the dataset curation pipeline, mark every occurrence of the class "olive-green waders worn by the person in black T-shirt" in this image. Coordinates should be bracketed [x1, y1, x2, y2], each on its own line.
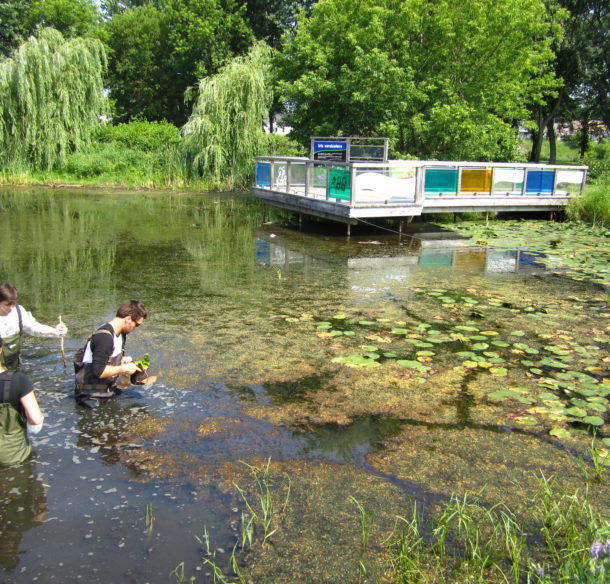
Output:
[0, 371, 32, 464]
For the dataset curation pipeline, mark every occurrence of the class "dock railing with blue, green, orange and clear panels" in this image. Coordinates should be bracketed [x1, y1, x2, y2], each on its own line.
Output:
[255, 156, 587, 210]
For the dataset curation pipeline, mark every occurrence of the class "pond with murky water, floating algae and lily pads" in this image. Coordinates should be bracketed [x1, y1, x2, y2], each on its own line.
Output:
[0, 189, 610, 584]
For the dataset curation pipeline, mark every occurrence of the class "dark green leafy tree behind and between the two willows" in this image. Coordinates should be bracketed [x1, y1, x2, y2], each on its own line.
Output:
[107, 0, 253, 125]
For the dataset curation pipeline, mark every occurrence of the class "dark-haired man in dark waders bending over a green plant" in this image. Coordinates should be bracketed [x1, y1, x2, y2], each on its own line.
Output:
[74, 300, 148, 408]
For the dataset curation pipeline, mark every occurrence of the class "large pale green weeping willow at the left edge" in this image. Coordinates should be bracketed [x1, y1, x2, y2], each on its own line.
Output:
[0, 28, 107, 169]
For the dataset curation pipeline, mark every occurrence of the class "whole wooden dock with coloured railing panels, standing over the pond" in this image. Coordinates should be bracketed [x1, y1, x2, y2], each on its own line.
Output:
[253, 156, 587, 225]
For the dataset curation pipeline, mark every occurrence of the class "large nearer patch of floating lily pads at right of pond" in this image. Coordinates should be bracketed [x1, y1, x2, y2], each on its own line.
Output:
[286, 280, 610, 454]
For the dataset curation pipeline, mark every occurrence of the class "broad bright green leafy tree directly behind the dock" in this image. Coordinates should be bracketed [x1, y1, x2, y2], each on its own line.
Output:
[280, 0, 555, 160]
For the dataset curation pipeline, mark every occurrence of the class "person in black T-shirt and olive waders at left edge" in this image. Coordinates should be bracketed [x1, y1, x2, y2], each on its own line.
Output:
[0, 339, 44, 465]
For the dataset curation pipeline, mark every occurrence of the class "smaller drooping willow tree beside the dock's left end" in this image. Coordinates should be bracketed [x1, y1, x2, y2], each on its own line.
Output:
[182, 43, 272, 189]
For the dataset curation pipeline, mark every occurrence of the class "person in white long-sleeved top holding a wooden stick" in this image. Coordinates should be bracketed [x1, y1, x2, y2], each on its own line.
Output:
[0, 284, 68, 369]
